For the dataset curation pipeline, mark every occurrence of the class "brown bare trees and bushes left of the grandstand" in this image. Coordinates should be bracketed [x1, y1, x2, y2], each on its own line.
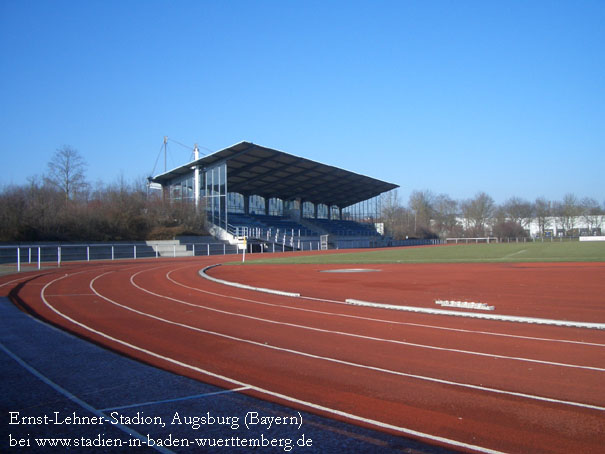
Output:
[0, 146, 207, 242]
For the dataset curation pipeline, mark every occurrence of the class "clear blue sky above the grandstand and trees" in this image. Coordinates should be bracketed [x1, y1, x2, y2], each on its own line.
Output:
[0, 0, 605, 204]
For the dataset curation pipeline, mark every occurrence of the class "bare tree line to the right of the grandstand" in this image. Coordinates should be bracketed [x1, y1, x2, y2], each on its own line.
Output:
[382, 190, 605, 239]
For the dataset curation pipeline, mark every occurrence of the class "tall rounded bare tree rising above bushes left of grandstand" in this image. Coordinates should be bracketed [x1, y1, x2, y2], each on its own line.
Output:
[45, 145, 88, 200]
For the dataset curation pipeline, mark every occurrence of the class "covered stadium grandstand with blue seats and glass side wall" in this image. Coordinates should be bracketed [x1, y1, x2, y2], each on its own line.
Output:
[150, 142, 398, 249]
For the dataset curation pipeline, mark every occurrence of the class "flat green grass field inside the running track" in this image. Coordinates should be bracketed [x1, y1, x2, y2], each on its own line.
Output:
[237, 241, 605, 264]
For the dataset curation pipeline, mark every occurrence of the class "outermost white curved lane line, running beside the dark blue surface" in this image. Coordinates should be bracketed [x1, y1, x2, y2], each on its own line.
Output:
[40, 275, 505, 454]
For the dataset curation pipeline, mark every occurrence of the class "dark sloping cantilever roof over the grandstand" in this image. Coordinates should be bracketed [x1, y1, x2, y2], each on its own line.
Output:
[152, 142, 399, 208]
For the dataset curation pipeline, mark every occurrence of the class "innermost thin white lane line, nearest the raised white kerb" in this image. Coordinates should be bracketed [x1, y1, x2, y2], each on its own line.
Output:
[195, 267, 605, 347]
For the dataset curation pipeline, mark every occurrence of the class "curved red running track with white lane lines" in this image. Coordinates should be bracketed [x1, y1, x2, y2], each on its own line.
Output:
[0, 257, 605, 453]
